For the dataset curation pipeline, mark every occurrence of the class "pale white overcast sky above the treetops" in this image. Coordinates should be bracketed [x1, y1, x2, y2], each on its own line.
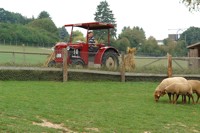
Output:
[0, 0, 200, 40]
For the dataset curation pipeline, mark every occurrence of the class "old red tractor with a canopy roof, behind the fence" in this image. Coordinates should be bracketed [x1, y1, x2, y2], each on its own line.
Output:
[48, 22, 119, 70]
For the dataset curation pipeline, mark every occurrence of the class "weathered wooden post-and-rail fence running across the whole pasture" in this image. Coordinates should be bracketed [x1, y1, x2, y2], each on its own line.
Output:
[0, 50, 200, 82]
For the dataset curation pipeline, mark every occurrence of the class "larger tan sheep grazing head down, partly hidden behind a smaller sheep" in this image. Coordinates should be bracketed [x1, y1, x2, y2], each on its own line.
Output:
[154, 77, 187, 102]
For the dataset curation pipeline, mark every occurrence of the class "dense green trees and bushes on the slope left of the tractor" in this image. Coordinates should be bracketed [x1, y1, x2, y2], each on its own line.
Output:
[0, 8, 59, 46]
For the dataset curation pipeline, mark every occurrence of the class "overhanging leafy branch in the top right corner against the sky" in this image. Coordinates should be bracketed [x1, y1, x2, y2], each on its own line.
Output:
[181, 0, 200, 11]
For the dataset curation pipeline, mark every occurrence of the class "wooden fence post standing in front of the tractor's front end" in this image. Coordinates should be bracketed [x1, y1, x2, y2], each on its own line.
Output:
[63, 48, 68, 82]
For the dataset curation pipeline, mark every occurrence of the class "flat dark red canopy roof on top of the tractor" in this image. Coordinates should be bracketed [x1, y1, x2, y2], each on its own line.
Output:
[65, 22, 114, 30]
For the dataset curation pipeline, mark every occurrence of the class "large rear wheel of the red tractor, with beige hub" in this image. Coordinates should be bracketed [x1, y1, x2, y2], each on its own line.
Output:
[102, 50, 119, 70]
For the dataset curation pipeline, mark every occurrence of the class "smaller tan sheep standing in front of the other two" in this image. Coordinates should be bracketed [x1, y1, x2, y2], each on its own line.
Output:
[164, 82, 194, 104]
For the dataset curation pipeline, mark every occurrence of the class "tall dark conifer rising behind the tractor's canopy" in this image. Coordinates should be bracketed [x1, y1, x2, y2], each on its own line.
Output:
[94, 1, 117, 40]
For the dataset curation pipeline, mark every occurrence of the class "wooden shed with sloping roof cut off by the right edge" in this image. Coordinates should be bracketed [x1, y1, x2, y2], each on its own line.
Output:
[187, 42, 200, 69]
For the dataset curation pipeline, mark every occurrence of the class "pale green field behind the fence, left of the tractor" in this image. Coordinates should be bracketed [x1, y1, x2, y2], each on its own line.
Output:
[0, 45, 52, 65]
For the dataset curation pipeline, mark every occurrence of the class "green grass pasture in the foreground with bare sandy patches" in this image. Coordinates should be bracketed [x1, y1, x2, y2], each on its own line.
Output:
[0, 81, 200, 133]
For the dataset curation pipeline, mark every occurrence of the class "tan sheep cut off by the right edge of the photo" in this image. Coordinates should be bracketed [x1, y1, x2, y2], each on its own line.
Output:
[188, 80, 200, 103]
